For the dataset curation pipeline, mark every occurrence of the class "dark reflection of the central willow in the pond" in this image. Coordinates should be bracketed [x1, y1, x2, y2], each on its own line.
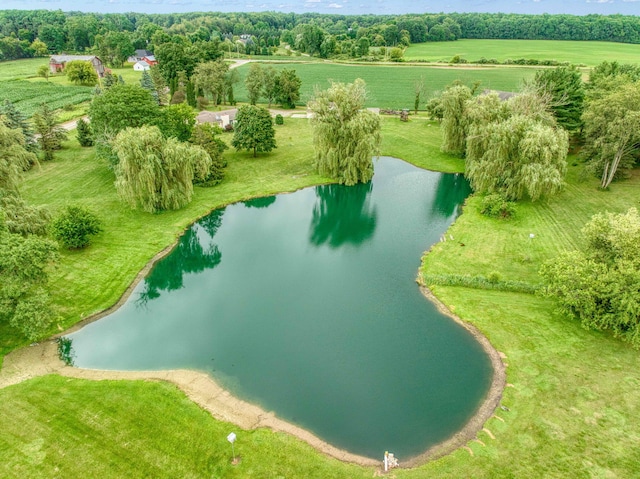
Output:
[311, 182, 377, 248]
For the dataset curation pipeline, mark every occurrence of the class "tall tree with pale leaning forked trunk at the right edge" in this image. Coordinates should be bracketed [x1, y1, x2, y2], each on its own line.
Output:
[582, 79, 640, 188]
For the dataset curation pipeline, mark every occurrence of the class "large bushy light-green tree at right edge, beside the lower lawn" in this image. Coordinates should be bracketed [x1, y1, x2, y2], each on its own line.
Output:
[540, 208, 640, 348]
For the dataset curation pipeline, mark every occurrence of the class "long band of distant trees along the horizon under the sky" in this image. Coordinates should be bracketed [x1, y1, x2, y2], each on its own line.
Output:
[0, 10, 640, 60]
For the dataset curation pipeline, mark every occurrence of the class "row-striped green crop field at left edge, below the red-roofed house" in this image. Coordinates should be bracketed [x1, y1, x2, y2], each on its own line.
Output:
[0, 80, 93, 116]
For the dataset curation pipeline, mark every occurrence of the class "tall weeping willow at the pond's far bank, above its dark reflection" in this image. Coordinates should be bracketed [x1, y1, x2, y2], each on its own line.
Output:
[309, 78, 381, 185]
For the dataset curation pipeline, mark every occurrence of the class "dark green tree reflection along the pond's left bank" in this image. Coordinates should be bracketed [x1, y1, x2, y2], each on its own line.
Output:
[138, 209, 224, 304]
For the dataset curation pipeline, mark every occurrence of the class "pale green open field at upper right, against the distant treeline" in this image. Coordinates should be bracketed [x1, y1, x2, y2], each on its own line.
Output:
[404, 40, 640, 66]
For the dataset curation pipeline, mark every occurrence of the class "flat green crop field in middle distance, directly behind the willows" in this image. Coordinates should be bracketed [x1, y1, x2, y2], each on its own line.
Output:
[236, 62, 535, 109]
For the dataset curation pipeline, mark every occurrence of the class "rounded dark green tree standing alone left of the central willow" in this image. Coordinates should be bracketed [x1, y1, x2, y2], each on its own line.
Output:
[231, 105, 276, 157]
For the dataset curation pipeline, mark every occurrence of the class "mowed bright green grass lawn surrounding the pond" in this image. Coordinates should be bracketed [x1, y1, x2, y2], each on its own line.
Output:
[0, 117, 640, 479]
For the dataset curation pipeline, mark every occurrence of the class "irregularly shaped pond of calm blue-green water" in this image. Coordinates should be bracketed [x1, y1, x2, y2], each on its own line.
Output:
[69, 157, 492, 460]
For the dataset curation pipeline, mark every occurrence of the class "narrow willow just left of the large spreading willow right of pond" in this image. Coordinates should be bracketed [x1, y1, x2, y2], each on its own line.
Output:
[441, 85, 472, 155]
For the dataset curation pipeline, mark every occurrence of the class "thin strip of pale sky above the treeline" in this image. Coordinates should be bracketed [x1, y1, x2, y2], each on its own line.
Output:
[0, 0, 640, 15]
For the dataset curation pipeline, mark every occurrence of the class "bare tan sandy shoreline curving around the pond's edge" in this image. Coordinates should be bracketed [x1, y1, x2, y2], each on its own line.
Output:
[0, 228, 506, 467]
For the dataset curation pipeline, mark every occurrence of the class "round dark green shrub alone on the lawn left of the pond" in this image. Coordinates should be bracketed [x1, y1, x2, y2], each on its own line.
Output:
[51, 206, 102, 249]
